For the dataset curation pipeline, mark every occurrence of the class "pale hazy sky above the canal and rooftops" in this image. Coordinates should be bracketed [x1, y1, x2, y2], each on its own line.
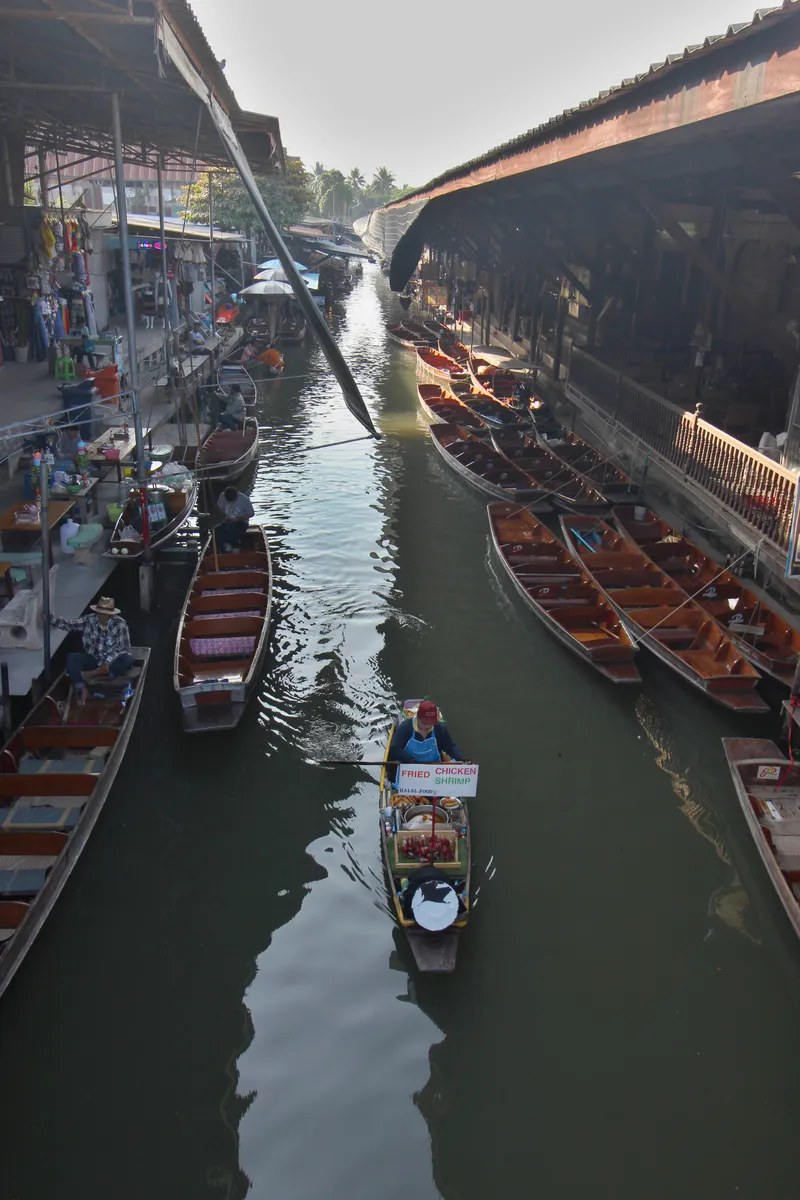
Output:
[192, 0, 775, 185]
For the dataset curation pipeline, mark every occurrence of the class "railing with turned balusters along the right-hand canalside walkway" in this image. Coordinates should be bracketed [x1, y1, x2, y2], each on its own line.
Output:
[567, 347, 798, 550]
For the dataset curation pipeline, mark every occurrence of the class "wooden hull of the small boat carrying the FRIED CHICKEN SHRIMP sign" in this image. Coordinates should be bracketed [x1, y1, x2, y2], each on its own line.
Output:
[378, 700, 471, 974]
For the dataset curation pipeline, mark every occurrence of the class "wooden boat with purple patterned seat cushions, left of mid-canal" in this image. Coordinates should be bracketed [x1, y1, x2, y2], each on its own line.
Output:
[173, 526, 272, 733]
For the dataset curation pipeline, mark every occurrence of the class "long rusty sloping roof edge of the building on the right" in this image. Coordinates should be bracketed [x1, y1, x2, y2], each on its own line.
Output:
[386, 0, 800, 208]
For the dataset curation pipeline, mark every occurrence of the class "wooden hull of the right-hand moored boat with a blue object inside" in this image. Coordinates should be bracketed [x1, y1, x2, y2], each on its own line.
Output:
[559, 516, 769, 713]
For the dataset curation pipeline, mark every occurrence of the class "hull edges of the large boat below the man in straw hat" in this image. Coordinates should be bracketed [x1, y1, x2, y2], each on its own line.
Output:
[0, 647, 150, 996]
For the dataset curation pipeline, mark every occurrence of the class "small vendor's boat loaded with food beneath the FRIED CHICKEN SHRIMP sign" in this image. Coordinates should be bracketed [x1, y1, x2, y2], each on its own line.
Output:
[379, 700, 471, 972]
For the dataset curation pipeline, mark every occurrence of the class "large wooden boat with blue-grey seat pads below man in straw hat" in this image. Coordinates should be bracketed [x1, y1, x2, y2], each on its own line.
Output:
[0, 647, 150, 995]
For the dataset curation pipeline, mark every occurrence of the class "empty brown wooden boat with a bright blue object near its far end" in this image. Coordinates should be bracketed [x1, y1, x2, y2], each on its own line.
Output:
[560, 516, 769, 713]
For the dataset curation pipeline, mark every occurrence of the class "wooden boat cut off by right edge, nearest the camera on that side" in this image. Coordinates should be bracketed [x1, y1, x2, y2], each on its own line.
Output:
[722, 738, 800, 935]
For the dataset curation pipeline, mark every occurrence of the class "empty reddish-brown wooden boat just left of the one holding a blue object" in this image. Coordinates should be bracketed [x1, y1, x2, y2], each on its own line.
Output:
[486, 504, 642, 683]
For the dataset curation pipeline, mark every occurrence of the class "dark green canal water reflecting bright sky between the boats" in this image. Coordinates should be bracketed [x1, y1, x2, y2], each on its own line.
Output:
[0, 268, 800, 1200]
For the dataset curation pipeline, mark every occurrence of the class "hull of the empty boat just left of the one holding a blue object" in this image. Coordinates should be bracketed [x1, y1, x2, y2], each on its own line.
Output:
[486, 504, 642, 683]
